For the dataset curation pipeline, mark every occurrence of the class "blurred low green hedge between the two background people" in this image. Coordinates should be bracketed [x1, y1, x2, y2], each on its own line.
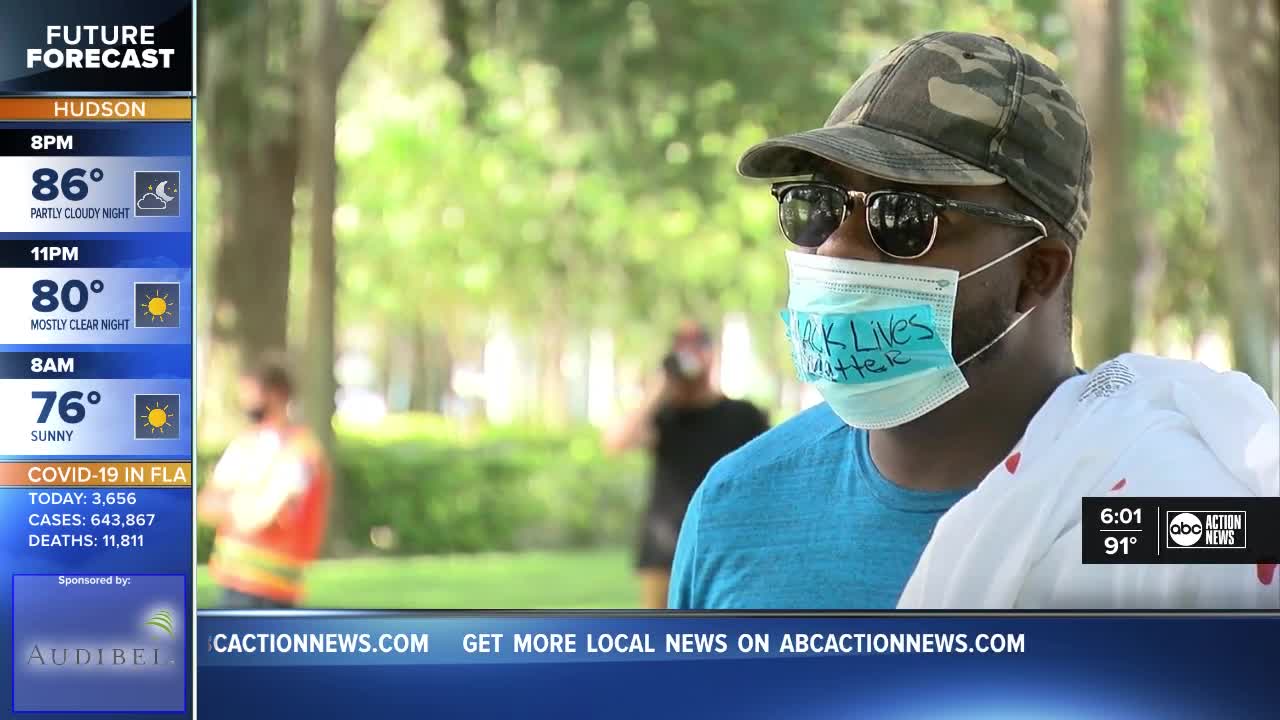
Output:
[197, 415, 648, 562]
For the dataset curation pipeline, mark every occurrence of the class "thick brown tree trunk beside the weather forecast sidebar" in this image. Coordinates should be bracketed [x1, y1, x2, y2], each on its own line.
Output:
[197, 4, 298, 434]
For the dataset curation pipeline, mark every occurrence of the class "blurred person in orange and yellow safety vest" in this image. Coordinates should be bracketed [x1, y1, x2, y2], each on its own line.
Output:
[197, 359, 329, 610]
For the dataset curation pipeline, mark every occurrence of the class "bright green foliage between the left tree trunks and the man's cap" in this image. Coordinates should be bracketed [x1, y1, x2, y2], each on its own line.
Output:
[339, 0, 1052, 368]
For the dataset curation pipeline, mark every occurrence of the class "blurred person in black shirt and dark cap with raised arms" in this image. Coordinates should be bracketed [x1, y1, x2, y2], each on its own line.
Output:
[604, 322, 769, 609]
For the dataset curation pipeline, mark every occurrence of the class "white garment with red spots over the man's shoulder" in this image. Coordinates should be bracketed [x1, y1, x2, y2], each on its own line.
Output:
[899, 354, 1280, 610]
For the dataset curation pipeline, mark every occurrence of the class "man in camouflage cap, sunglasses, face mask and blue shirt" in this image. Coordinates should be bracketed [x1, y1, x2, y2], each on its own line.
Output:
[669, 32, 1280, 609]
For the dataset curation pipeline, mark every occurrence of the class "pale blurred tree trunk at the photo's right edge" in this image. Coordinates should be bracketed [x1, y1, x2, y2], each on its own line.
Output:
[1193, 0, 1280, 400]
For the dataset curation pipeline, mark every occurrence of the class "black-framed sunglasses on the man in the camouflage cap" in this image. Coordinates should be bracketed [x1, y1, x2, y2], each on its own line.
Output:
[772, 181, 1047, 260]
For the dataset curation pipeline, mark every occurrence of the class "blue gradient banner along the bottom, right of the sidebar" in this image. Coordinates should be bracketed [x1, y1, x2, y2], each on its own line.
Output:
[196, 612, 1280, 720]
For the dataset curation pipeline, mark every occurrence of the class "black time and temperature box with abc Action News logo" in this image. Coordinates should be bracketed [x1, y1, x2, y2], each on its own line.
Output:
[1080, 497, 1280, 565]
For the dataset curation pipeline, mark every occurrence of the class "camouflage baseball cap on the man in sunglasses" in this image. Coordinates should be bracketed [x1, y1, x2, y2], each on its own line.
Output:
[737, 32, 1093, 240]
